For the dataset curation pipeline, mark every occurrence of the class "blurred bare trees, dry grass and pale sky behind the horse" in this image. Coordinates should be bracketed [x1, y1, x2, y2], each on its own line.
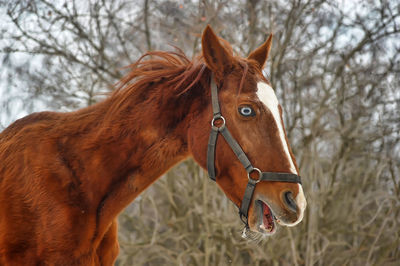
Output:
[0, 0, 400, 265]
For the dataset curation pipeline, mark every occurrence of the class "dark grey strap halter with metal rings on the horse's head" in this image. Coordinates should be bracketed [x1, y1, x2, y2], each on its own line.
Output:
[207, 76, 301, 229]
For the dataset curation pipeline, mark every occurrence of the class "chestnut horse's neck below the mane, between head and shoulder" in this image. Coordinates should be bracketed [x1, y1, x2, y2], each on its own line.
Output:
[60, 78, 207, 234]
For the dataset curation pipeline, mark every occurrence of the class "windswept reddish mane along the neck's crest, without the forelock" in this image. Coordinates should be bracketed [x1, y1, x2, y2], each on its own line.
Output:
[96, 49, 209, 127]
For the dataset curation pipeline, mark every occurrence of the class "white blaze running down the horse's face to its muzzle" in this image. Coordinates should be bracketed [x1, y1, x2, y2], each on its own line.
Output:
[257, 82, 307, 226]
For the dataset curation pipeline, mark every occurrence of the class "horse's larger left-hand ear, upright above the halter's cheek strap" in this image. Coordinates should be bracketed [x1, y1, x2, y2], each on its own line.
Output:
[201, 25, 233, 79]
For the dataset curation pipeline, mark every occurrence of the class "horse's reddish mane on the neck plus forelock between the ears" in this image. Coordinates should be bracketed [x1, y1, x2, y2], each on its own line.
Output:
[95, 44, 254, 133]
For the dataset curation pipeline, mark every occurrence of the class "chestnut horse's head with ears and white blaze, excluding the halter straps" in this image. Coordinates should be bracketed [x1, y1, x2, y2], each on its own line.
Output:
[189, 27, 306, 235]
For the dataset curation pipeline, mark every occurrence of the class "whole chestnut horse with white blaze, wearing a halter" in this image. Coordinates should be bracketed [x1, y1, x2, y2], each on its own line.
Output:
[0, 26, 306, 265]
